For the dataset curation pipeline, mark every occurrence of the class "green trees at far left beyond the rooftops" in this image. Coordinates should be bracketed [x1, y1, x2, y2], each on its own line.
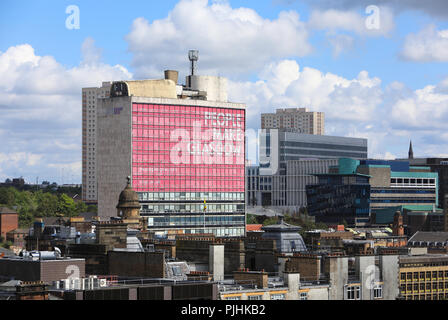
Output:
[0, 187, 97, 228]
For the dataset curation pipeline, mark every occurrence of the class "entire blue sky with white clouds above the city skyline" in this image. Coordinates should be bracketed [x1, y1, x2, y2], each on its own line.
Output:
[0, 0, 448, 183]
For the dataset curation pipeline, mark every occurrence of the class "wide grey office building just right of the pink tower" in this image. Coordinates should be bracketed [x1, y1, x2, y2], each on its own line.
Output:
[246, 129, 367, 209]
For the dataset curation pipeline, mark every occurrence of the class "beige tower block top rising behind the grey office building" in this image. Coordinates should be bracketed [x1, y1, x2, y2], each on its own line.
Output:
[261, 108, 325, 135]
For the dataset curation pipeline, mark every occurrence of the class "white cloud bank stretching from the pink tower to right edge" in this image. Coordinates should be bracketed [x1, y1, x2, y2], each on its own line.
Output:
[229, 60, 448, 159]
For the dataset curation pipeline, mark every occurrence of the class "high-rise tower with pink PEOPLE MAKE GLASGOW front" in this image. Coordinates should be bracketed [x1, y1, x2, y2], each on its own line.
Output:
[97, 75, 245, 236]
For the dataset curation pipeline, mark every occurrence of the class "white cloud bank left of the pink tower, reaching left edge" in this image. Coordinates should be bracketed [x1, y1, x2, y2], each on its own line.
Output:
[0, 38, 132, 181]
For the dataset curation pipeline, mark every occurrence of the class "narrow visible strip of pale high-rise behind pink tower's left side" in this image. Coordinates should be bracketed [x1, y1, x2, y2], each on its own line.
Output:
[82, 82, 111, 203]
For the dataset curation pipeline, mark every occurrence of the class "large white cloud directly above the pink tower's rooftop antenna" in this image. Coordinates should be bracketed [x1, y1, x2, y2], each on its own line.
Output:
[126, 0, 312, 77]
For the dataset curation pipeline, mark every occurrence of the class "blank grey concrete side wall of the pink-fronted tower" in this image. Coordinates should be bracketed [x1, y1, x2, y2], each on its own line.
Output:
[96, 97, 132, 217]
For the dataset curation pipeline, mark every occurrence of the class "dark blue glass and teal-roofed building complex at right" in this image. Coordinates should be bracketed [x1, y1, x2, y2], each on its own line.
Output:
[307, 158, 438, 225]
